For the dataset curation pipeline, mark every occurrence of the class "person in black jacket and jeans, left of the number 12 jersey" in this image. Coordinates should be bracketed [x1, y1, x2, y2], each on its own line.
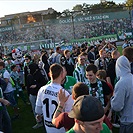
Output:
[24, 55, 47, 128]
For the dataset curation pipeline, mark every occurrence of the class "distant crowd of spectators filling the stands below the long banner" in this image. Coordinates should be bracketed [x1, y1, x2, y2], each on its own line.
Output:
[0, 18, 131, 44]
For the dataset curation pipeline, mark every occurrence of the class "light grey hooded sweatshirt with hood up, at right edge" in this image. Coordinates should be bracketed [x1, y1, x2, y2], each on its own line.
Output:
[111, 56, 133, 125]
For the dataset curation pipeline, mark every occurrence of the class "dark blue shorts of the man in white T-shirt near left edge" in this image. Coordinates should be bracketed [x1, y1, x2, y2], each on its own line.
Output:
[4, 91, 17, 107]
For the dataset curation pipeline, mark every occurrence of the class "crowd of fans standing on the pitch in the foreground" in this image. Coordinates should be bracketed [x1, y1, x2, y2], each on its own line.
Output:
[0, 41, 133, 133]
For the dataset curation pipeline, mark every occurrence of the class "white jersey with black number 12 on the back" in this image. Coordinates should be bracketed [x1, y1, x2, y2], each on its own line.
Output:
[36, 83, 73, 133]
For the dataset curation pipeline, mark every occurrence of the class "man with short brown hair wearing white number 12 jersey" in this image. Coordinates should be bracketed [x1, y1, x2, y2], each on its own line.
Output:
[35, 64, 73, 133]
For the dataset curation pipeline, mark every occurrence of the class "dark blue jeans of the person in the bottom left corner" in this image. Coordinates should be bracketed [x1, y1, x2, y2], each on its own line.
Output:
[0, 106, 12, 133]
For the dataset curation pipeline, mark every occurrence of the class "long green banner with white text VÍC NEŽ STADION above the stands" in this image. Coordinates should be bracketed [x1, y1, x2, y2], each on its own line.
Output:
[44, 11, 130, 25]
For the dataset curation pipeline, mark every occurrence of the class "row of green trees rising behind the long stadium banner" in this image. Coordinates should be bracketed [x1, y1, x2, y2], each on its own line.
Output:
[59, 0, 127, 17]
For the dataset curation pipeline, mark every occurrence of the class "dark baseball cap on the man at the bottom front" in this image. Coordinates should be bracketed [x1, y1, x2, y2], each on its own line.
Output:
[68, 95, 104, 122]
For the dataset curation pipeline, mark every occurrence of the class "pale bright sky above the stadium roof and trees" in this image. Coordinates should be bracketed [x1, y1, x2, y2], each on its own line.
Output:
[0, 0, 125, 17]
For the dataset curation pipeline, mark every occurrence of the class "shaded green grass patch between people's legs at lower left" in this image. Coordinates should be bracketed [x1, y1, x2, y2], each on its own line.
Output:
[8, 93, 45, 133]
